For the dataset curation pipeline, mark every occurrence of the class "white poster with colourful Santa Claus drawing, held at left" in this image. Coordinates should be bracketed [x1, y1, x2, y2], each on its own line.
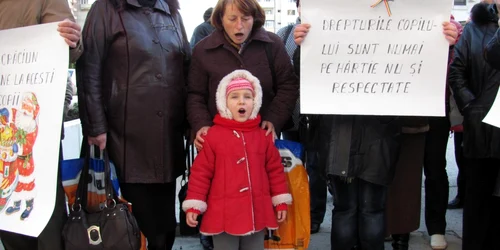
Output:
[0, 23, 68, 237]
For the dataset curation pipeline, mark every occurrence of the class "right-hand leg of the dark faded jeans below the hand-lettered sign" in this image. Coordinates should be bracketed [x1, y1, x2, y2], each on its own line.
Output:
[358, 180, 387, 250]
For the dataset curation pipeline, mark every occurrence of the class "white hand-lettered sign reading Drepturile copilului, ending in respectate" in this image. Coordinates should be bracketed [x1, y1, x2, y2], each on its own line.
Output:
[300, 0, 452, 116]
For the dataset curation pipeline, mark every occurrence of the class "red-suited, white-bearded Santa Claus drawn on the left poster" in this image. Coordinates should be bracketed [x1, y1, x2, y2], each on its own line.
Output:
[5, 93, 40, 220]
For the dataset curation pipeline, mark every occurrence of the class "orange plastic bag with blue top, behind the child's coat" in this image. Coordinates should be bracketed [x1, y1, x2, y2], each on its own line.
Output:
[264, 140, 311, 250]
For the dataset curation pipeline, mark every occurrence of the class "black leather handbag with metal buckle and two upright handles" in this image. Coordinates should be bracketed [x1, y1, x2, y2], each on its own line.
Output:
[63, 151, 141, 250]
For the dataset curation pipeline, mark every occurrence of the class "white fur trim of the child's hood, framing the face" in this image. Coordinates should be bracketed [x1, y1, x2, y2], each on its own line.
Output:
[215, 69, 262, 120]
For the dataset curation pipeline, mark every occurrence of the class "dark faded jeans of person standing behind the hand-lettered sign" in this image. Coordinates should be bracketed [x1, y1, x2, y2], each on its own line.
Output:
[330, 177, 387, 250]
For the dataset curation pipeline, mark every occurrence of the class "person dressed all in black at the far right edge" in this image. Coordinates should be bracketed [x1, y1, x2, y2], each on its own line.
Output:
[449, 3, 500, 250]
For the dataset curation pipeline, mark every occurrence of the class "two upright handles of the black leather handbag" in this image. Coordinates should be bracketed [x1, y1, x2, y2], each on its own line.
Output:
[71, 146, 117, 211]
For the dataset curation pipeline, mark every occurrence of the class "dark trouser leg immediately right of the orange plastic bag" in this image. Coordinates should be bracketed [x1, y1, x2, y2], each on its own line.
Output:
[306, 150, 327, 233]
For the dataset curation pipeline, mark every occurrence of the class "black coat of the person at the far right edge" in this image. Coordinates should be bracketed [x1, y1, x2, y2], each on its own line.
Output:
[448, 4, 500, 158]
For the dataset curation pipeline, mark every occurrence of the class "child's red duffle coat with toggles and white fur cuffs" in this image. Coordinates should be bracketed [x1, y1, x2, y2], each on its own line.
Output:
[182, 115, 292, 235]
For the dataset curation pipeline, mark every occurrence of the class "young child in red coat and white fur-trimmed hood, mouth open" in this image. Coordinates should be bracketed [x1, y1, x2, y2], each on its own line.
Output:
[182, 70, 292, 250]
